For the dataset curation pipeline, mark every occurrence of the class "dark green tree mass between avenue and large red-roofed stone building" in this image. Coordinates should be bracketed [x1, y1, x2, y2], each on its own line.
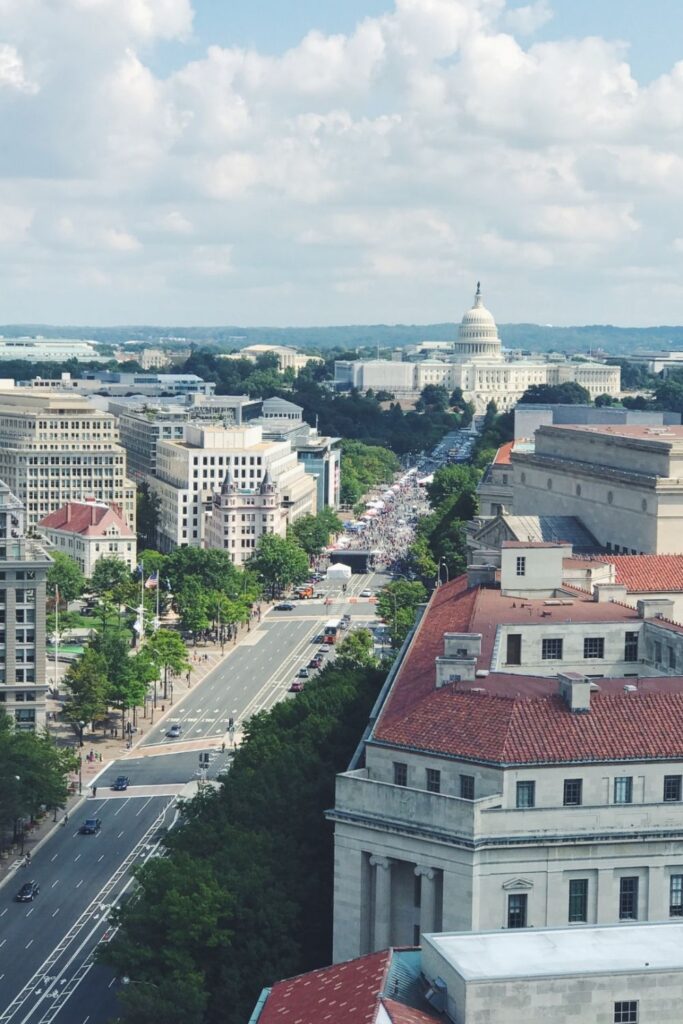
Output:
[100, 667, 383, 1024]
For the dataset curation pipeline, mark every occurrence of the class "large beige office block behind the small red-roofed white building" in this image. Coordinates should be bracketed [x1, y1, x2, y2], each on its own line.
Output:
[0, 388, 135, 529]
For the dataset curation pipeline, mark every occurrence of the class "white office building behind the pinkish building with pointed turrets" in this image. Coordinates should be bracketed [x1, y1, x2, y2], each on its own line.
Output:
[150, 423, 316, 551]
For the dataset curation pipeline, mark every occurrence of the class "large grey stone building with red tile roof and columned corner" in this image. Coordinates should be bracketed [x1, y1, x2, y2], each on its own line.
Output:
[328, 543, 683, 961]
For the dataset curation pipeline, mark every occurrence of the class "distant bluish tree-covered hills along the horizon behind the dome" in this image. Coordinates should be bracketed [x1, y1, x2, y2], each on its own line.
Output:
[0, 324, 683, 354]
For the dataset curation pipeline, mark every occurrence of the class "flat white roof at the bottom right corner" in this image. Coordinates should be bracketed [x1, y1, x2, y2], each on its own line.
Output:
[423, 923, 683, 981]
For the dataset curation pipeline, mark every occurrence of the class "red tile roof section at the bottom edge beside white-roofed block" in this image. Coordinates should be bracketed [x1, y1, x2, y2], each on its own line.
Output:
[258, 949, 440, 1024]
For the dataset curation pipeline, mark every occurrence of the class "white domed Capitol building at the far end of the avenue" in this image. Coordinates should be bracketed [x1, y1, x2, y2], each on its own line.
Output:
[335, 284, 621, 414]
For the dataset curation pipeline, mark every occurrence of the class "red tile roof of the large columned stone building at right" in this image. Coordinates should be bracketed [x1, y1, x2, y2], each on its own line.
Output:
[371, 577, 683, 764]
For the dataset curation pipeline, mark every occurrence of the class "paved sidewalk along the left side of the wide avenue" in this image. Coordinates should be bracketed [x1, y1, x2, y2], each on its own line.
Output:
[0, 605, 262, 886]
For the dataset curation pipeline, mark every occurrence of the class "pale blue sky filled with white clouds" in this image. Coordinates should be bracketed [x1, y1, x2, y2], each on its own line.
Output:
[0, 0, 683, 326]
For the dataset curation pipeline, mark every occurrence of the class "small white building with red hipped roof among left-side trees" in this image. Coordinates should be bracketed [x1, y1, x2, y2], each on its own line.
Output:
[37, 500, 137, 580]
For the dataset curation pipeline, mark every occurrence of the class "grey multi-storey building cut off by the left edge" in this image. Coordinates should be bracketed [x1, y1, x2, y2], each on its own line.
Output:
[0, 481, 51, 732]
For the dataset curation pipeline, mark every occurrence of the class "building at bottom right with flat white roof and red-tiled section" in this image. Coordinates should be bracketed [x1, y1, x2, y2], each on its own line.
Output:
[249, 922, 683, 1024]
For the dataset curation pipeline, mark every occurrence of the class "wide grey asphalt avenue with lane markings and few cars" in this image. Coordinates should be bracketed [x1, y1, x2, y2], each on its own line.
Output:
[0, 574, 385, 1024]
